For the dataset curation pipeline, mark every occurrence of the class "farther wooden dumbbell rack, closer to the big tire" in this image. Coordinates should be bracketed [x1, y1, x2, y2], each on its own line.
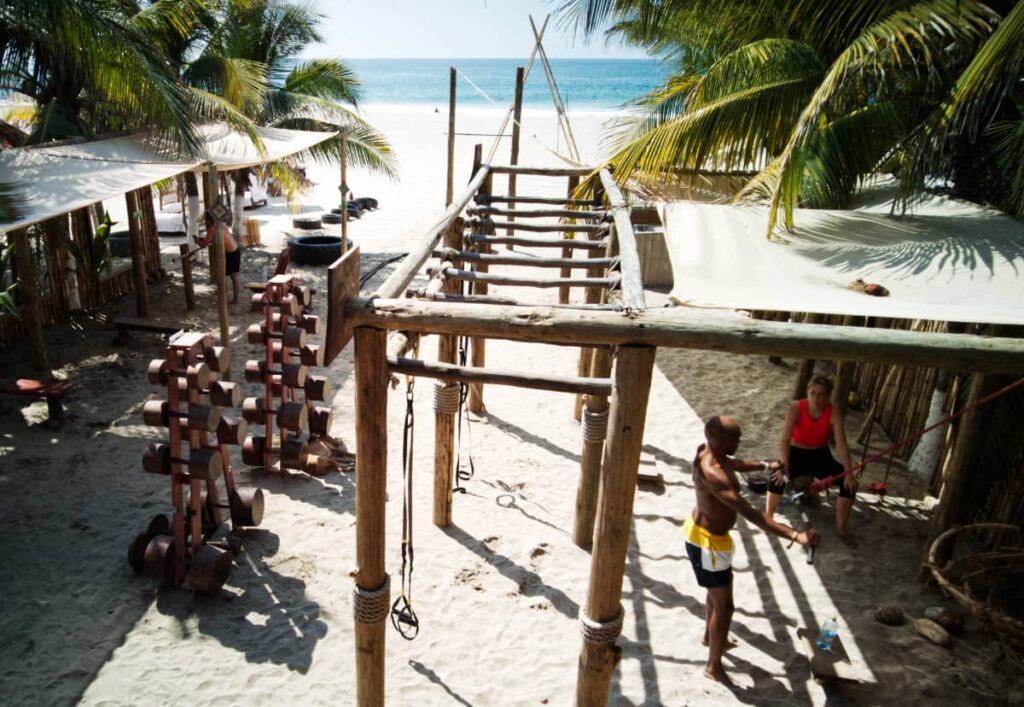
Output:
[242, 275, 331, 471]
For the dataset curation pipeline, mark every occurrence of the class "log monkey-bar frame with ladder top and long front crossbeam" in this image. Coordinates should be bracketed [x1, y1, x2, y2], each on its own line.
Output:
[327, 156, 1024, 705]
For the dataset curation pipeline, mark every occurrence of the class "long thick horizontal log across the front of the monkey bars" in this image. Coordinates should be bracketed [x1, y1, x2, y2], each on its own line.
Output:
[347, 297, 1024, 373]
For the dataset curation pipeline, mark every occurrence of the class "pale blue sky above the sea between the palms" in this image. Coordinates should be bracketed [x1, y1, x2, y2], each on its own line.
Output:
[304, 0, 644, 59]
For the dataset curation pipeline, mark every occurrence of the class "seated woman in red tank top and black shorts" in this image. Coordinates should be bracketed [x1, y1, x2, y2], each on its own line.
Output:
[765, 376, 857, 547]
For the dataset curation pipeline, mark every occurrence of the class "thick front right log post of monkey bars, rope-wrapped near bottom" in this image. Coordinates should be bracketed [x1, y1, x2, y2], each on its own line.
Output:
[577, 346, 656, 706]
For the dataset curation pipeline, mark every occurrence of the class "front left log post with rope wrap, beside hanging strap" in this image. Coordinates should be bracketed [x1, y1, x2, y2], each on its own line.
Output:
[355, 327, 389, 705]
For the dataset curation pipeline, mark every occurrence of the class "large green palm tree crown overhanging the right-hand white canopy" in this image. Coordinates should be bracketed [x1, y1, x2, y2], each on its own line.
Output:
[560, 0, 1024, 228]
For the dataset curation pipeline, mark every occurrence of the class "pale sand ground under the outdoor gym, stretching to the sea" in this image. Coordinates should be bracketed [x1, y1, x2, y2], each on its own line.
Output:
[0, 107, 1024, 707]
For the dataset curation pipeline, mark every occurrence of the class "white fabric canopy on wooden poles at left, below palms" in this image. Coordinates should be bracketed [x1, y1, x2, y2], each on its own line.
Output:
[0, 123, 337, 233]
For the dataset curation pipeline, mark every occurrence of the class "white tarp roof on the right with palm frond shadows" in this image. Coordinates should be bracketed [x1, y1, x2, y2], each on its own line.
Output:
[663, 192, 1024, 324]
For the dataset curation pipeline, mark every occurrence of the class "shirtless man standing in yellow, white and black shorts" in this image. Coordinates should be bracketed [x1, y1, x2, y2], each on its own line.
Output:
[683, 416, 818, 681]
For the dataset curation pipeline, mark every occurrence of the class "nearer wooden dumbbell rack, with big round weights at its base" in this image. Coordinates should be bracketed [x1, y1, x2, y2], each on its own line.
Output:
[128, 333, 263, 593]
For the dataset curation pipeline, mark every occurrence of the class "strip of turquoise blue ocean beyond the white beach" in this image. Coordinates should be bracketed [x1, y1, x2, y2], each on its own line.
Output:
[345, 58, 667, 113]
